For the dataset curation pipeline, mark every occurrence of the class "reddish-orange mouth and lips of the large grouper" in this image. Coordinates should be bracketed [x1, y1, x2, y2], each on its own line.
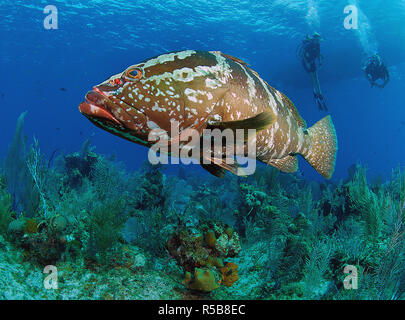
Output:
[79, 88, 122, 126]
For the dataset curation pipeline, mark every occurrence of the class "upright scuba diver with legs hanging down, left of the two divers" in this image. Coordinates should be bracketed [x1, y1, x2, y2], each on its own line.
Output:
[297, 32, 328, 110]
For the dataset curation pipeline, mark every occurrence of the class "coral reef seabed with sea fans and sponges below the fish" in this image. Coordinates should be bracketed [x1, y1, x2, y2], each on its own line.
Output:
[0, 115, 405, 300]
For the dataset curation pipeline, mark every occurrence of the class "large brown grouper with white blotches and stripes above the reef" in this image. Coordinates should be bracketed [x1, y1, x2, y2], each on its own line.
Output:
[79, 50, 337, 179]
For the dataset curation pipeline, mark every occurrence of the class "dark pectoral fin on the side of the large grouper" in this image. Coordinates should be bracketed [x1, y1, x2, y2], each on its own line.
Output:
[207, 111, 276, 140]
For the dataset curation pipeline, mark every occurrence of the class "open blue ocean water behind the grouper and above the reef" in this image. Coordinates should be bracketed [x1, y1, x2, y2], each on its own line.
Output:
[0, 0, 405, 179]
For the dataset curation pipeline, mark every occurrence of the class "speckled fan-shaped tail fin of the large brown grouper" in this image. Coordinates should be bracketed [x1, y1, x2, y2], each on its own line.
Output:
[303, 116, 338, 179]
